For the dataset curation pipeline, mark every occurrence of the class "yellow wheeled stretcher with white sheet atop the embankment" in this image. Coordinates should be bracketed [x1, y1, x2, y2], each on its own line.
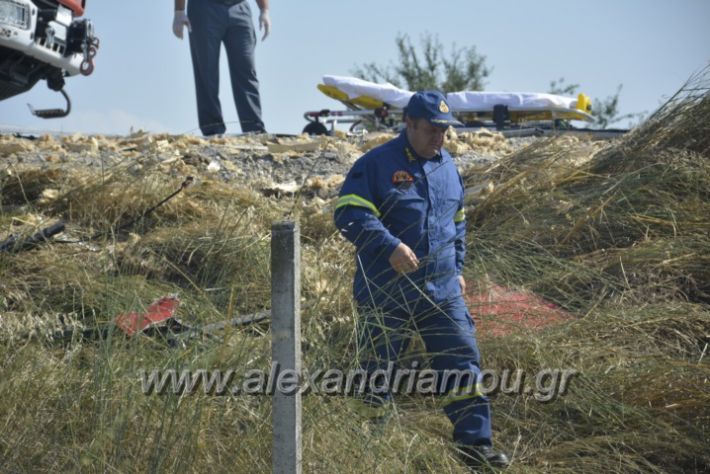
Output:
[303, 75, 593, 134]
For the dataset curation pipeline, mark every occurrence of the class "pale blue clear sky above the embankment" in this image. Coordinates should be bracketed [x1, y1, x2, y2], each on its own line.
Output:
[0, 0, 710, 135]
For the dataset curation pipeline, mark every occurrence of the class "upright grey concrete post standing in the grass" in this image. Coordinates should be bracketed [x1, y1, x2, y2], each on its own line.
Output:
[271, 222, 301, 474]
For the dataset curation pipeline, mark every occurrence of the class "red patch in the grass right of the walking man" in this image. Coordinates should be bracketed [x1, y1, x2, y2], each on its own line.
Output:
[466, 283, 573, 338]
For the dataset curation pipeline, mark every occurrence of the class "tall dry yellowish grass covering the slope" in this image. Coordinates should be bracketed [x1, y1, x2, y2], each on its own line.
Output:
[0, 68, 710, 473]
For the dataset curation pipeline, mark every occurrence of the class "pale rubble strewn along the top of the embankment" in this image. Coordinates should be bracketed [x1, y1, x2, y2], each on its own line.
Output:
[0, 130, 544, 213]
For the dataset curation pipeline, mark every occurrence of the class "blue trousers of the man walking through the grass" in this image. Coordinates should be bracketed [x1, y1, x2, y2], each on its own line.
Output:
[358, 295, 491, 446]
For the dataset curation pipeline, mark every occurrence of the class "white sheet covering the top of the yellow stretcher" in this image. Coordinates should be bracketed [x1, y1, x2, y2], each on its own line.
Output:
[323, 76, 577, 112]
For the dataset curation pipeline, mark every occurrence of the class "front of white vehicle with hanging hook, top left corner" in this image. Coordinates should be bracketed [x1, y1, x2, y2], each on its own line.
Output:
[0, 0, 99, 118]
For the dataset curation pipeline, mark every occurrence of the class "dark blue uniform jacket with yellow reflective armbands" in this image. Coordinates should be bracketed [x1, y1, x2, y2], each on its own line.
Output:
[335, 131, 466, 309]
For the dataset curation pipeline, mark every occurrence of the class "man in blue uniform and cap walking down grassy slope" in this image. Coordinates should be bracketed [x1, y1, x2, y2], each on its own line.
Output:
[335, 91, 509, 467]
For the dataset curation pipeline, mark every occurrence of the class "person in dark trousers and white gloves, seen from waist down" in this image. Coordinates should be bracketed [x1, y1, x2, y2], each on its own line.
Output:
[173, 0, 271, 136]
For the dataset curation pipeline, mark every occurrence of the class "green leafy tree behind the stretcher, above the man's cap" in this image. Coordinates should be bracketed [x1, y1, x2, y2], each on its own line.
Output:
[352, 33, 491, 92]
